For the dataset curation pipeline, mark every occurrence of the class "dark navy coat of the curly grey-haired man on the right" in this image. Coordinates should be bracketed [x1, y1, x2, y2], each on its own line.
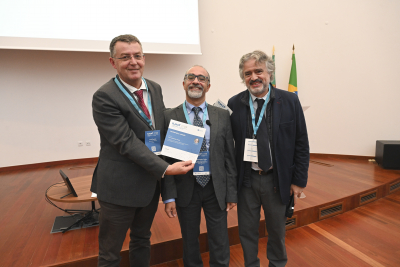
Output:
[228, 86, 310, 204]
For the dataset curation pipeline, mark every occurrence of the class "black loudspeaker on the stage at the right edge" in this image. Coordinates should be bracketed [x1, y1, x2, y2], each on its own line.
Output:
[375, 140, 400, 170]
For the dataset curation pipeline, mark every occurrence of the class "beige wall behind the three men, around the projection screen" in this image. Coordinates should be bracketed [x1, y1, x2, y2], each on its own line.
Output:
[0, 0, 400, 167]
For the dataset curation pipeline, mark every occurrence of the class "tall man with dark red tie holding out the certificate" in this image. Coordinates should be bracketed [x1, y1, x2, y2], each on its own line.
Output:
[91, 35, 194, 267]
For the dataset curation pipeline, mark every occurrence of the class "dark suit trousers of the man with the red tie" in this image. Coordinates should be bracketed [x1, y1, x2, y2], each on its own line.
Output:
[98, 183, 160, 267]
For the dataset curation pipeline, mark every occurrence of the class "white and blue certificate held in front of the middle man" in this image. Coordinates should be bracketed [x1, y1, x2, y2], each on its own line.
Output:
[161, 120, 206, 163]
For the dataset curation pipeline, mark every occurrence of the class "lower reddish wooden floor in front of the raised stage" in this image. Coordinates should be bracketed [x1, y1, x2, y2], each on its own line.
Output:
[153, 190, 400, 267]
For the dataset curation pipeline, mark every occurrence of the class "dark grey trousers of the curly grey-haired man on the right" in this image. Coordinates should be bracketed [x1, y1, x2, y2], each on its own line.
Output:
[238, 171, 287, 267]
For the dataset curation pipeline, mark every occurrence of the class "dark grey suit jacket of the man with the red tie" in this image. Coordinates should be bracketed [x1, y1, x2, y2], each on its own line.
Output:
[91, 78, 168, 207]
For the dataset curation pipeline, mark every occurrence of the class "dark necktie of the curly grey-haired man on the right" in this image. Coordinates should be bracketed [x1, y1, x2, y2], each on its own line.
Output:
[256, 98, 272, 171]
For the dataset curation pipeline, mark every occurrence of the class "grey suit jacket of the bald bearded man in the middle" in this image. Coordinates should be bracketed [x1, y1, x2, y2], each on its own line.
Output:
[161, 104, 237, 210]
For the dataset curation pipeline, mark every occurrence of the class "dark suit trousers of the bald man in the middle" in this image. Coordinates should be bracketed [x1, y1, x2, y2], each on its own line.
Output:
[176, 179, 230, 267]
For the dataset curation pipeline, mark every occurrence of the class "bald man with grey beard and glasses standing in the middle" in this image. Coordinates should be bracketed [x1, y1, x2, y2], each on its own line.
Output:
[162, 66, 237, 267]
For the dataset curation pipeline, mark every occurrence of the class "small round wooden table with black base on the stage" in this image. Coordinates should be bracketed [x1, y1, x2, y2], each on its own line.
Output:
[46, 175, 99, 233]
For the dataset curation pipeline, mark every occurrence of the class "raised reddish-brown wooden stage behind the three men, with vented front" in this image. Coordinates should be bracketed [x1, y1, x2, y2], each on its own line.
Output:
[0, 154, 400, 266]
